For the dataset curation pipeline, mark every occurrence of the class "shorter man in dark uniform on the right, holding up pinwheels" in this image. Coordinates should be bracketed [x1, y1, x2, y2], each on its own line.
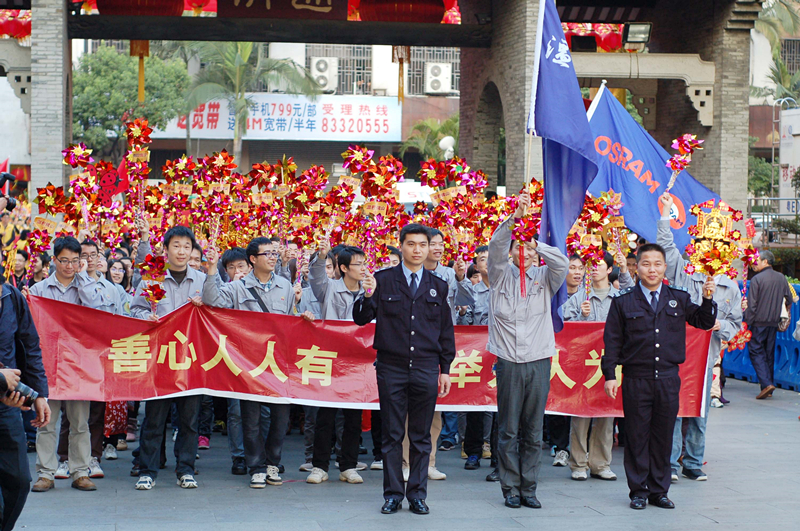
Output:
[602, 243, 717, 509]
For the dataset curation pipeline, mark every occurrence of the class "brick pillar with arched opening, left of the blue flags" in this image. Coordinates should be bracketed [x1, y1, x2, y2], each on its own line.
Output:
[458, 0, 542, 193]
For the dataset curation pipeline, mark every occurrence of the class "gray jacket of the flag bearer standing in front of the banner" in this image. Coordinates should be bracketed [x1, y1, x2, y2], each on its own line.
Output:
[486, 215, 569, 363]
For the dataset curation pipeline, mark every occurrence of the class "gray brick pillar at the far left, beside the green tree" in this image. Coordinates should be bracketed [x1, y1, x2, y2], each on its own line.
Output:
[31, 0, 72, 194]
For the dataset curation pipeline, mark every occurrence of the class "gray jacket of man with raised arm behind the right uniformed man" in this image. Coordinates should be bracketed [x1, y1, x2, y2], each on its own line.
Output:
[656, 219, 742, 367]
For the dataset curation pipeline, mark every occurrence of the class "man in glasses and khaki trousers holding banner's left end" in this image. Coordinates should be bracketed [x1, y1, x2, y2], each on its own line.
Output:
[23, 236, 108, 492]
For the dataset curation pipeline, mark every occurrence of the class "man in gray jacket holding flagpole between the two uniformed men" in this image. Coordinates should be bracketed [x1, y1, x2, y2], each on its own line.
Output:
[487, 193, 569, 509]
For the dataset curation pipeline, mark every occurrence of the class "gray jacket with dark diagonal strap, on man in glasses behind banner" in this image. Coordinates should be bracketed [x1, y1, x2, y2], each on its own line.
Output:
[203, 271, 294, 315]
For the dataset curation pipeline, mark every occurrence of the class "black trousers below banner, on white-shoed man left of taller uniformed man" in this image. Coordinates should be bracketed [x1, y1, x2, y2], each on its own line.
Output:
[311, 407, 361, 471]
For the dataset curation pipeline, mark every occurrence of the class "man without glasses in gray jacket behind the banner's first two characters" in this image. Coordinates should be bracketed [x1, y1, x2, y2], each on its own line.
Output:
[131, 226, 206, 490]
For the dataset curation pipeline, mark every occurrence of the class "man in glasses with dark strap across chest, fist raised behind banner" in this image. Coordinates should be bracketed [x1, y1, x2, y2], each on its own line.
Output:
[203, 238, 314, 489]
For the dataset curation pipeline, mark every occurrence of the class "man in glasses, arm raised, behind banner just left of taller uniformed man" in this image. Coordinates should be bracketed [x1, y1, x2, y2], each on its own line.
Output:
[306, 240, 367, 483]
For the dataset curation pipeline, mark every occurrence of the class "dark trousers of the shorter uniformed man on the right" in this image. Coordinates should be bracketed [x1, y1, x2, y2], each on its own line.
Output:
[622, 375, 681, 498]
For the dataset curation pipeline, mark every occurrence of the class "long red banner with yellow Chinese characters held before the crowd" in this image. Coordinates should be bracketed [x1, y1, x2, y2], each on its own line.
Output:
[31, 297, 710, 417]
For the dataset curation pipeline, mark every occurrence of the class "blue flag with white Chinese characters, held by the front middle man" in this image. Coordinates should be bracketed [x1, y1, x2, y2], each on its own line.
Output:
[528, 0, 597, 332]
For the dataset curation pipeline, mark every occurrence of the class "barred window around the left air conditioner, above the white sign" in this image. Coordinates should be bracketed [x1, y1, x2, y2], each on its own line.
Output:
[306, 44, 372, 94]
